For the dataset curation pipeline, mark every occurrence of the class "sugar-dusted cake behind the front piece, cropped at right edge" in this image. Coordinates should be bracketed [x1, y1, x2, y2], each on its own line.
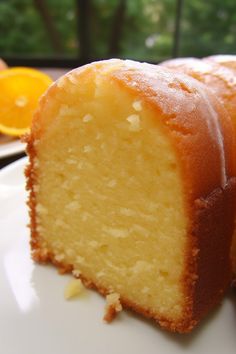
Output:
[162, 55, 236, 278]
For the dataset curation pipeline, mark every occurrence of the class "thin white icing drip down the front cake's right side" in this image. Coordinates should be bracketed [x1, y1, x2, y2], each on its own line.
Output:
[198, 87, 227, 188]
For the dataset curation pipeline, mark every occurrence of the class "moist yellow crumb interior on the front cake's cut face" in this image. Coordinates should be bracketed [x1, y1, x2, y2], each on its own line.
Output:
[34, 71, 187, 321]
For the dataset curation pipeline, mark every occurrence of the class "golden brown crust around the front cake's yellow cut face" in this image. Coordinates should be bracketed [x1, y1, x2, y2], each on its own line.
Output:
[26, 61, 235, 333]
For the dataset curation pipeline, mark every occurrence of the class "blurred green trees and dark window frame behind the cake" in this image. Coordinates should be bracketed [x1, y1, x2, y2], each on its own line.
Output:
[0, 0, 236, 67]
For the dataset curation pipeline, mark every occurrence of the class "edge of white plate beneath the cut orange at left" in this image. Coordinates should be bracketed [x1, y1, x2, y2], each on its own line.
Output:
[0, 134, 25, 159]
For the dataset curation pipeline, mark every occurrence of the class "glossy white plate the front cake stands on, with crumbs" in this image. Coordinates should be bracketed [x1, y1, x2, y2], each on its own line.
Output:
[0, 158, 236, 354]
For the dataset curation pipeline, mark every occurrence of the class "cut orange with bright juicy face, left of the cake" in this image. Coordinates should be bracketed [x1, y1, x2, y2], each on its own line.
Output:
[0, 67, 52, 136]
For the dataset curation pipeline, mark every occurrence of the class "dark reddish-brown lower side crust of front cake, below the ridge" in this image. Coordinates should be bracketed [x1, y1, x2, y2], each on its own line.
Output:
[188, 177, 236, 319]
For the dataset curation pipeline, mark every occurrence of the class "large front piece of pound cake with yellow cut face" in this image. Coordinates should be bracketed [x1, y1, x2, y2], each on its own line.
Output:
[26, 60, 235, 332]
